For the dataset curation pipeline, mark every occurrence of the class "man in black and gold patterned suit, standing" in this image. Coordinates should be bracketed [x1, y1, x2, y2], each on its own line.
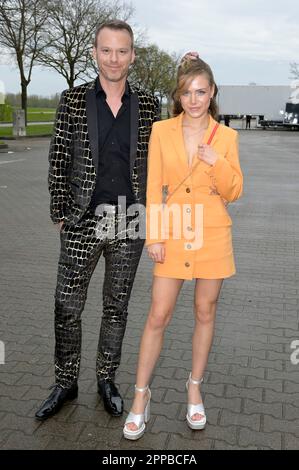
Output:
[35, 20, 159, 420]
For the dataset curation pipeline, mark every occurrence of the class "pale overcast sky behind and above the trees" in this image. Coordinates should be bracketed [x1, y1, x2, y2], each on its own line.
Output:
[0, 0, 299, 95]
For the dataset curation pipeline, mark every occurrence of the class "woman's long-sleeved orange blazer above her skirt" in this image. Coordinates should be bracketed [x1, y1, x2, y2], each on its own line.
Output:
[146, 113, 243, 245]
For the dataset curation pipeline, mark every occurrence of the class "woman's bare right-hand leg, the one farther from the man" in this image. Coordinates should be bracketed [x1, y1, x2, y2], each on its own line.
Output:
[188, 279, 223, 420]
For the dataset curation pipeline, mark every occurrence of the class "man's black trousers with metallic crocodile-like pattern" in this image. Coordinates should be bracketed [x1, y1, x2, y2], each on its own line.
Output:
[55, 207, 144, 388]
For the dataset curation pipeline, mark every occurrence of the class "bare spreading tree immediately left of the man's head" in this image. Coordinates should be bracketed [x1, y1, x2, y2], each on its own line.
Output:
[39, 0, 133, 88]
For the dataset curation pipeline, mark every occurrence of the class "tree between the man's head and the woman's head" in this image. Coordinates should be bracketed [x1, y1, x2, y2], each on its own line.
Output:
[130, 44, 178, 106]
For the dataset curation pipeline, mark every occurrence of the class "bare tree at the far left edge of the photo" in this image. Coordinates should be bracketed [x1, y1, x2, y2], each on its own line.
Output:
[0, 0, 47, 123]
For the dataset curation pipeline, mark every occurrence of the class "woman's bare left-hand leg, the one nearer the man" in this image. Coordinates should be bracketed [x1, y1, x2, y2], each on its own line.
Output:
[127, 276, 183, 431]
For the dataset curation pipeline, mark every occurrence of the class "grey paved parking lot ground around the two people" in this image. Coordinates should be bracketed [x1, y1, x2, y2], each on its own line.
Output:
[0, 131, 299, 450]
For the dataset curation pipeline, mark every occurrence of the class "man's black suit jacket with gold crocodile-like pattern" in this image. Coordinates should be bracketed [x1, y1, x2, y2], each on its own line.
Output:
[48, 80, 159, 224]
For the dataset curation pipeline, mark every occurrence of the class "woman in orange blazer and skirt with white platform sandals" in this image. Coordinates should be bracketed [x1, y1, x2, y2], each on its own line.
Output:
[123, 54, 243, 440]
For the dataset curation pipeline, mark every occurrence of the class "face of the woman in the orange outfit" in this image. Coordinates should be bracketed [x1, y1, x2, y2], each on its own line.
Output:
[180, 74, 214, 118]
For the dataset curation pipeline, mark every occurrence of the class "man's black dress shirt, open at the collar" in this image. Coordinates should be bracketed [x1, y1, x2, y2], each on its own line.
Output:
[90, 79, 135, 210]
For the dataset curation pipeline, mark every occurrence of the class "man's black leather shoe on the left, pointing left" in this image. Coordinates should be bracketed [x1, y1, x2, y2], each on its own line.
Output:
[35, 384, 78, 421]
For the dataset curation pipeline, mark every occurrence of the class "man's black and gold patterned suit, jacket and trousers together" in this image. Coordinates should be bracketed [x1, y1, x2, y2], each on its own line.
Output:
[49, 81, 159, 388]
